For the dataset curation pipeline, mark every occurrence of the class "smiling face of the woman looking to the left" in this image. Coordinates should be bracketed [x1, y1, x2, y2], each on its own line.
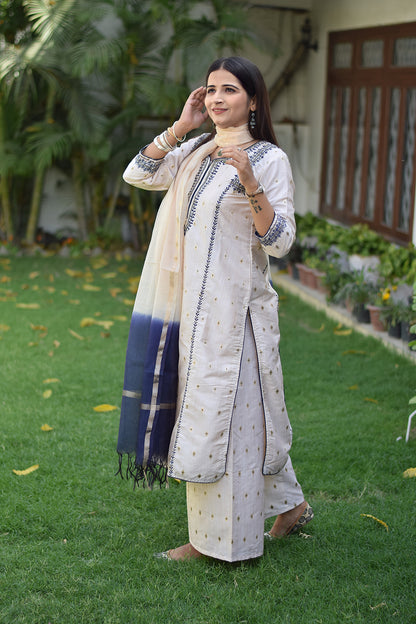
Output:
[205, 69, 256, 128]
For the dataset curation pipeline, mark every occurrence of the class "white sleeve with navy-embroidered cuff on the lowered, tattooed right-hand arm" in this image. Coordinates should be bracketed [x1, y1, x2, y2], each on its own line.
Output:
[256, 148, 296, 258]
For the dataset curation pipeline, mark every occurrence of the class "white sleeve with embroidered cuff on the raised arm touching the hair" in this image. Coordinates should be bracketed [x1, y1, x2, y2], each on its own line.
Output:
[123, 135, 206, 191]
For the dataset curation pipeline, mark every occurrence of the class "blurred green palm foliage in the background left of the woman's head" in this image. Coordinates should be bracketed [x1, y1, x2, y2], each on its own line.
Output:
[0, 0, 272, 247]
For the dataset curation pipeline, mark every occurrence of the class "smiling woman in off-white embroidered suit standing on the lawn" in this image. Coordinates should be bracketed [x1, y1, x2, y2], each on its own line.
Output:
[118, 57, 313, 561]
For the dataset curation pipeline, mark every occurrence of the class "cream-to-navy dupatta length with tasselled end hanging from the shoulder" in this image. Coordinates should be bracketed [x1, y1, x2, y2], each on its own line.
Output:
[117, 141, 215, 487]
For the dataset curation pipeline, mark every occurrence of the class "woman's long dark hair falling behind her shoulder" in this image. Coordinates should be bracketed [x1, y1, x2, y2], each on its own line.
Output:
[205, 56, 278, 145]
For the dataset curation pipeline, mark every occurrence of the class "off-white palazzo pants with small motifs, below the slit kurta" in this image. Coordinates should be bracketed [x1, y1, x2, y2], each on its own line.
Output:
[186, 317, 304, 561]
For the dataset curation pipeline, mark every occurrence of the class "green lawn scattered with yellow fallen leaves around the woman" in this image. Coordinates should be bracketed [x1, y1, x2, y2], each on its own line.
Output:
[0, 257, 416, 624]
